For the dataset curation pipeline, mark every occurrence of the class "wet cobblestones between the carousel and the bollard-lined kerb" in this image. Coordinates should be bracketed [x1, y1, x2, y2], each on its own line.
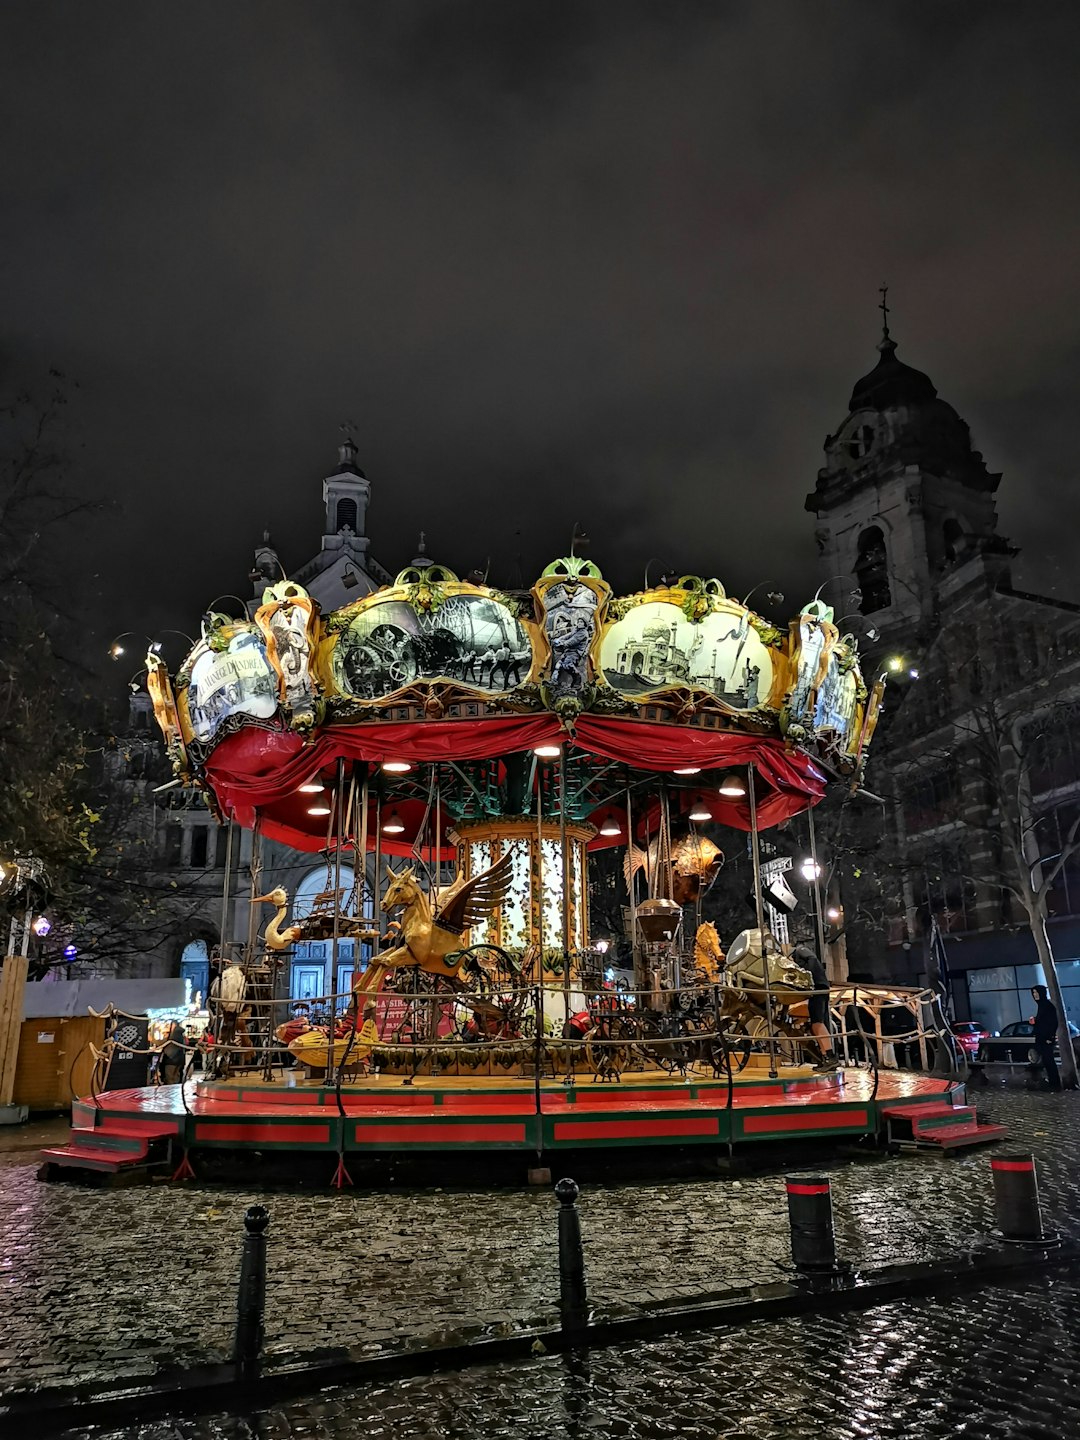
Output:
[0, 1092, 1080, 1405]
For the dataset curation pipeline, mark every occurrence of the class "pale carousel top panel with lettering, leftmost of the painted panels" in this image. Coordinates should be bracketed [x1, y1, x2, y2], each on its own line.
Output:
[180, 625, 278, 744]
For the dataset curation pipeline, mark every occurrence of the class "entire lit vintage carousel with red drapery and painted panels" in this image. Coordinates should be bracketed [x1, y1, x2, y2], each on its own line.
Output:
[46, 554, 996, 1185]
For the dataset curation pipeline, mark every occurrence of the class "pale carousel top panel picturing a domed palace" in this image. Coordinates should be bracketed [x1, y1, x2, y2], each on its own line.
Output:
[600, 582, 773, 710]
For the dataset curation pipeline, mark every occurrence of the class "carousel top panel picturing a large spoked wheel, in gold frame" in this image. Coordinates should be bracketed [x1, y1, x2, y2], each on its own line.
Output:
[331, 566, 533, 700]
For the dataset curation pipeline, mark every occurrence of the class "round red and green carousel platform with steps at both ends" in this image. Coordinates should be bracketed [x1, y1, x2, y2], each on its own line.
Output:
[42, 1067, 1004, 1175]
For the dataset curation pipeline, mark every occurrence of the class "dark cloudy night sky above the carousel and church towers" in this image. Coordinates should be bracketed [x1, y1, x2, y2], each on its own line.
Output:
[0, 0, 1080, 662]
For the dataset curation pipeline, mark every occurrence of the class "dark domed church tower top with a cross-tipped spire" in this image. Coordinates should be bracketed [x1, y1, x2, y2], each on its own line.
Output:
[806, 295, 1015, 644]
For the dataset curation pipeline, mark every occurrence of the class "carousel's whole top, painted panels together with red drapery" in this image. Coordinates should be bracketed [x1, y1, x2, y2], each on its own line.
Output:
[147, 556, 880, 850]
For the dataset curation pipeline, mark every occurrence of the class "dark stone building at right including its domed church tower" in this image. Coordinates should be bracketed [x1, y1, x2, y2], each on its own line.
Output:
[806, 312, 1080, 1030]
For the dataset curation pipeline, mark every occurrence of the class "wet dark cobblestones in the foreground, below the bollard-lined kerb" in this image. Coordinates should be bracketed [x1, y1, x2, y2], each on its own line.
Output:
[88, 1284, 1080, 1440]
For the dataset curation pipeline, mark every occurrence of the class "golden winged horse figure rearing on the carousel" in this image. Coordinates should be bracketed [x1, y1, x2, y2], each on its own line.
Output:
[353, 851, 513, 994]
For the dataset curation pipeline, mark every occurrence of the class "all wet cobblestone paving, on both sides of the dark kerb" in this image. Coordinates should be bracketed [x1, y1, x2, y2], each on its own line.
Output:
[0, 1092, 1080, 1440]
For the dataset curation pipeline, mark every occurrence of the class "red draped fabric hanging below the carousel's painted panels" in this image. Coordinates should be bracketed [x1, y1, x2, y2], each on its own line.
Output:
[206, 714, 825, 854]
